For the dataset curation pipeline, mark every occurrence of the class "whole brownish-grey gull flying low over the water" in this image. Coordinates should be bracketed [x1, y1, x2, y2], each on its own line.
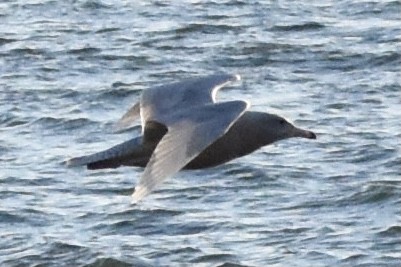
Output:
[69, 74, 316, 201]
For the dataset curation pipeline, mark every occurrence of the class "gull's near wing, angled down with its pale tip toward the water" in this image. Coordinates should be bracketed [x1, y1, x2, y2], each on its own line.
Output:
[132, 101, 248, 202]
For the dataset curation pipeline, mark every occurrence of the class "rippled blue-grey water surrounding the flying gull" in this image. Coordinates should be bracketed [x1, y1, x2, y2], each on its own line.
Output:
[0, 0, 401, 267]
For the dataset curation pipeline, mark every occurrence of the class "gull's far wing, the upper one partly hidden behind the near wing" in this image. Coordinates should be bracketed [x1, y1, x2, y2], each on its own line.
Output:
[140, 74, 240, 126]
